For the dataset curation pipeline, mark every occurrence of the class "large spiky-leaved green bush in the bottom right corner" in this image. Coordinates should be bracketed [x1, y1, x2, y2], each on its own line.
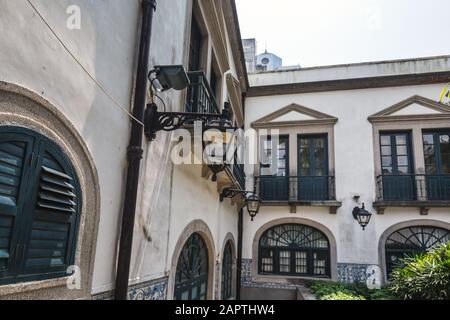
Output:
[390, 242, 450, 300]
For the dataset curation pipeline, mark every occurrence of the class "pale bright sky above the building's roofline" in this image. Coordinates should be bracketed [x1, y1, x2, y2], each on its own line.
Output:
[236, 0, 450, 67]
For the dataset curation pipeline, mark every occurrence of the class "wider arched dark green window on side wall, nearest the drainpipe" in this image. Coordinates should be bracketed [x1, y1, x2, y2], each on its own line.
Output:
[175, 233, 208, 300]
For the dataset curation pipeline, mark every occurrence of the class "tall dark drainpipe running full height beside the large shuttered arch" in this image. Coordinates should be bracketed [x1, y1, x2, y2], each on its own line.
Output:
[114, 0, 156, 300]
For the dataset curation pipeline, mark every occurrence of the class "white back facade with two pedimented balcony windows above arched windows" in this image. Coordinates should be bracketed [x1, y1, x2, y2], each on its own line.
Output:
[243, 57, 450, 296]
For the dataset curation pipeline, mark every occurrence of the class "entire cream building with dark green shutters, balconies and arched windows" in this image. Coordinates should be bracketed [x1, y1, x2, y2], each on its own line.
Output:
[0, 0, 450, 300]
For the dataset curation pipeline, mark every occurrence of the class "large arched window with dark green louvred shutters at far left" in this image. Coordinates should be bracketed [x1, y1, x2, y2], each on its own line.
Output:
[0, 127, 81, 284]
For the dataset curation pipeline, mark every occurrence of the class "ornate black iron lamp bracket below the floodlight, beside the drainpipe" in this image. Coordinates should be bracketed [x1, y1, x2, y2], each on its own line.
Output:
[144, 103, 238, 141]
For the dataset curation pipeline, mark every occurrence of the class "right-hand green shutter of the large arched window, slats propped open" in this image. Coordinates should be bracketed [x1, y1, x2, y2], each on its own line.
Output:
[23, 145, 79, 275]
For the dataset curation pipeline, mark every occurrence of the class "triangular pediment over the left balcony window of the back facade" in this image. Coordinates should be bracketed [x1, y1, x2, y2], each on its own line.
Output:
[252, 103, 338, 128]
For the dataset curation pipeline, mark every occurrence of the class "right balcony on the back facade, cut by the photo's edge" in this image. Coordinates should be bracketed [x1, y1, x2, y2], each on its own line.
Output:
[374, 174, 450, 215]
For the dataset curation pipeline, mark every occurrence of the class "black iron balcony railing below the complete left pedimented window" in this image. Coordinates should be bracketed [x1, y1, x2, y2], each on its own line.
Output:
[255, 176, 336, 202]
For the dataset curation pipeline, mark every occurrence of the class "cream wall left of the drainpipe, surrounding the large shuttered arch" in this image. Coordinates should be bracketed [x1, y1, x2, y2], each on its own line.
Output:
[0, 0, 142, 292]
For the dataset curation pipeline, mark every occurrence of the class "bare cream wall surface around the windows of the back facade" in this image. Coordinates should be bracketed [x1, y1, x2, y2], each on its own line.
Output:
[243, 84, 450, 264]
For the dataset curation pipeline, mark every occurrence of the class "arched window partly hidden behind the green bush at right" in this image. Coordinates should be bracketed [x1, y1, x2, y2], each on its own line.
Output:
[385, 226, 450, 275]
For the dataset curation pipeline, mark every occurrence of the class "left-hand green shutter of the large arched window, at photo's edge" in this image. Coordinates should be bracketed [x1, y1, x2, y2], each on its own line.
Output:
[0, 134, 32, 277]
